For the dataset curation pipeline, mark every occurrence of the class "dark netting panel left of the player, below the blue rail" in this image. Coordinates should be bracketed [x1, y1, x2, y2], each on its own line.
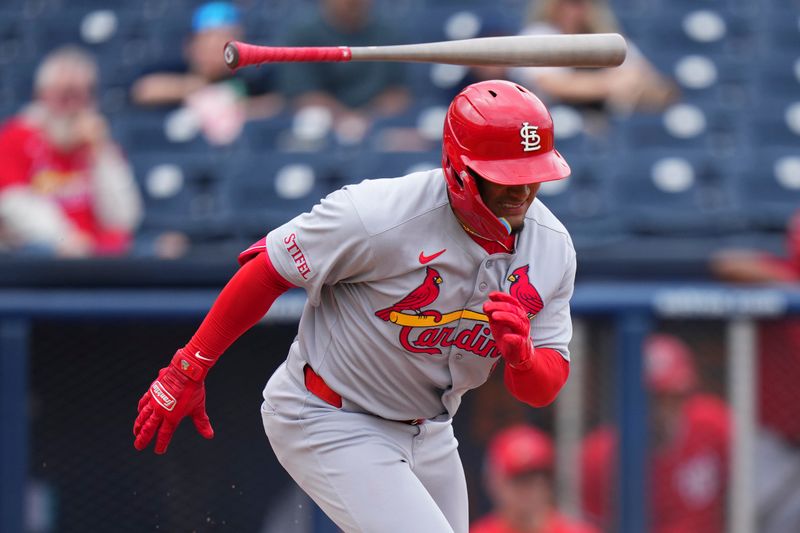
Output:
[28, 321, 295, 533]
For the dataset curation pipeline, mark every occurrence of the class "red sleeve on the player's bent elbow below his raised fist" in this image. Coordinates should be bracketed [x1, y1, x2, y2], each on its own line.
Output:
[503, 348, 569, 407]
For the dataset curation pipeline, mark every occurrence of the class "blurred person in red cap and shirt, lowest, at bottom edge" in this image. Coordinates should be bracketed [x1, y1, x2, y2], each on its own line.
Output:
[470, 425, 597, 533]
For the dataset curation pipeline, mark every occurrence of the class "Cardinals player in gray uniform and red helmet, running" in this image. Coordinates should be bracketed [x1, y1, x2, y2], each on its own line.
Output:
[134, 81, 575, 533]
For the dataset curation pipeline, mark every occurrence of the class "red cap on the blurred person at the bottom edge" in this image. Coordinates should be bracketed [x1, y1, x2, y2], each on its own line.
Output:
[487, 425, 555, 476]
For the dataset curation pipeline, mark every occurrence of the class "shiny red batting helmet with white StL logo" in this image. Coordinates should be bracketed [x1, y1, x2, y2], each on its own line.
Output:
[442, 80, 570, 240]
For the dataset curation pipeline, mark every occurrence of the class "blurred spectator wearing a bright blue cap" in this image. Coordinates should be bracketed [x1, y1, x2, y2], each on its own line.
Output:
[131, 2, 283, 144]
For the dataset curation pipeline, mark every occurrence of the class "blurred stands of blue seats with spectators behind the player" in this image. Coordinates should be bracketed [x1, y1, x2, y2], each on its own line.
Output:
[0, 0, 800, 260]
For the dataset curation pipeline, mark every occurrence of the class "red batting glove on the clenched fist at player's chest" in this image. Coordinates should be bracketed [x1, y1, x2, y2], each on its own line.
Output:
[483, 291, 533, 370]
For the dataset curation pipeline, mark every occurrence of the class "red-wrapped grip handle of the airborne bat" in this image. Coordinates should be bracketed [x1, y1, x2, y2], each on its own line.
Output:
[223, 41, 352, 69]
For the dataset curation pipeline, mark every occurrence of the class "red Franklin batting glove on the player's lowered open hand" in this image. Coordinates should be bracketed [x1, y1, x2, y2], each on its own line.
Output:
[133, 349, 214, 454]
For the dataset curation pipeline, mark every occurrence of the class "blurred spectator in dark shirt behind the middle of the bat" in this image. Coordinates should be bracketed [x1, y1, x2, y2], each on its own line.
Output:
[281, 0, 409, 138]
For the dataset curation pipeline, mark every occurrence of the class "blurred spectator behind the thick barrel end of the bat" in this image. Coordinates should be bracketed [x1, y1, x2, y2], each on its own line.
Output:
[515, 0, 678, 122]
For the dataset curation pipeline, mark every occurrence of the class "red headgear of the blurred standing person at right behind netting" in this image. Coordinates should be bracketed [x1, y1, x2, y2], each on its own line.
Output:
[644, 334, 697, 394]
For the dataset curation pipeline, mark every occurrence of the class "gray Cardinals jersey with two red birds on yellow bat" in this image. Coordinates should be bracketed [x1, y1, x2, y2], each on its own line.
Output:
[266, 169, 575, 420]
